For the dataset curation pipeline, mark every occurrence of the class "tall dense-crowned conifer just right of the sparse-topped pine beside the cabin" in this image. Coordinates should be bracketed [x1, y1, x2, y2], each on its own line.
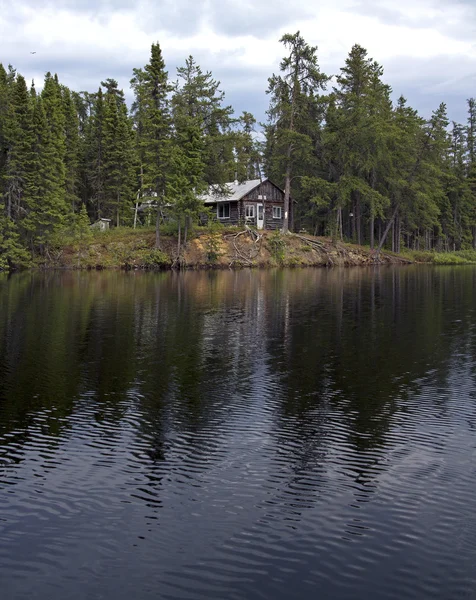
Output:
[327, 45, 392, 248]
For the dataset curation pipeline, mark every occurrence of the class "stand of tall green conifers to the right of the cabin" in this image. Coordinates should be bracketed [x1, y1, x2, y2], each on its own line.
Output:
[264, 33, 476, 252]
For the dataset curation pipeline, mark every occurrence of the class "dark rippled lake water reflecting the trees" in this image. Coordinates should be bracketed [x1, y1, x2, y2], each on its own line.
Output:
[0, 267, 476, 600]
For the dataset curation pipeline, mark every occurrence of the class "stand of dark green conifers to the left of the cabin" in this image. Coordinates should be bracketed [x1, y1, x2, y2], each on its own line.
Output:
[0, 44, 258, 269]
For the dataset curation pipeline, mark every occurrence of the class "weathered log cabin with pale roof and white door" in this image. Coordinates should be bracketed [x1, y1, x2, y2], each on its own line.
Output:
[203, 179, 292, 229]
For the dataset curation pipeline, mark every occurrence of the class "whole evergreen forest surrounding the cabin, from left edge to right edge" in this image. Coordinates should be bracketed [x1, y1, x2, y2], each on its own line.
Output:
[0, 32, 476, 270]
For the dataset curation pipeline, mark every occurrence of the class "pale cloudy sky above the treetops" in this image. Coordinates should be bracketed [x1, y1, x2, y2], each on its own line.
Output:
[0, 0, 476, 121]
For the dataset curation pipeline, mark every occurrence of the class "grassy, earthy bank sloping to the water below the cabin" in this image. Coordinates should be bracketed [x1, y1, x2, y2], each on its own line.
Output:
[37, 227, 414, 269]
